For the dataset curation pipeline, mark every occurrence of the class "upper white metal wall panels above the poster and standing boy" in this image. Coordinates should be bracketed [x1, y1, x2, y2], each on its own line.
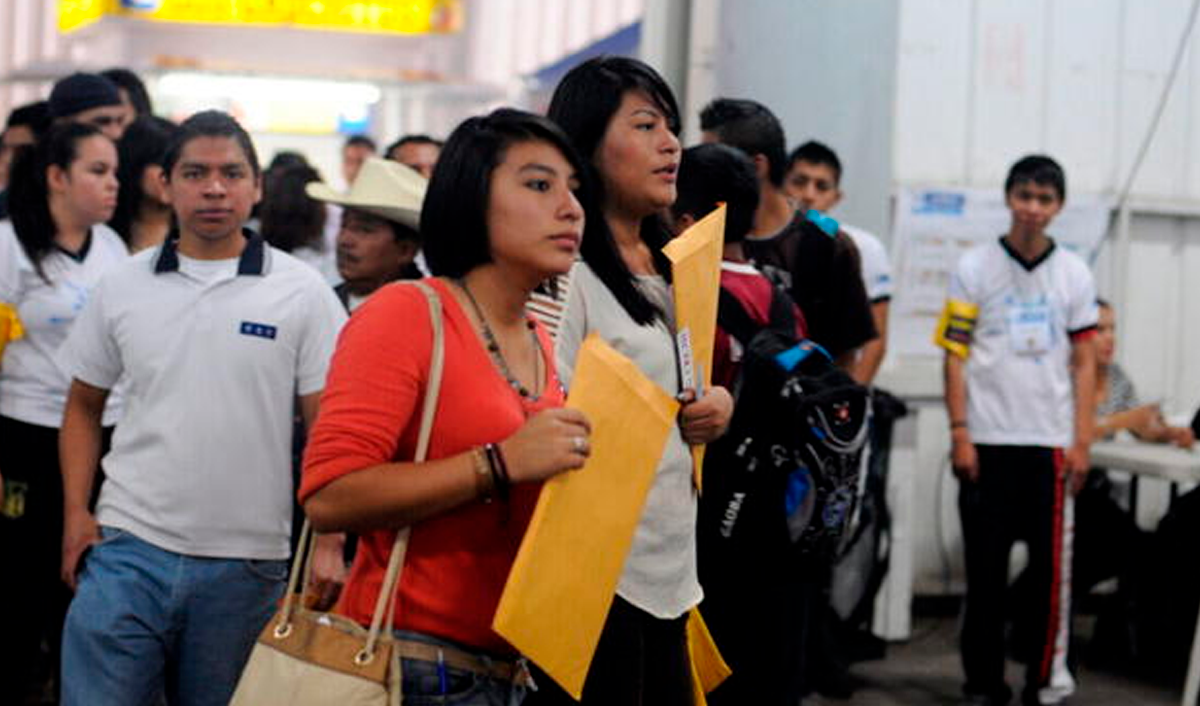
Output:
[893, 0, 1200, 201]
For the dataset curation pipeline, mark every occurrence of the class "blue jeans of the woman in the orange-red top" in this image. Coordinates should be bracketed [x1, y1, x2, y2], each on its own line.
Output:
[396, 630, 526, 706]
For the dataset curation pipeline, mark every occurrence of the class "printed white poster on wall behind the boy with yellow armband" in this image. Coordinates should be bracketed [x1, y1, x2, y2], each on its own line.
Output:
[888, 187, 1111, 357]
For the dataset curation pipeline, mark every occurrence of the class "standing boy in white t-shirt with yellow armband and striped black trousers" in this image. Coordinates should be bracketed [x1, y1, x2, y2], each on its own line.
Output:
[935, 156, 1097, 705]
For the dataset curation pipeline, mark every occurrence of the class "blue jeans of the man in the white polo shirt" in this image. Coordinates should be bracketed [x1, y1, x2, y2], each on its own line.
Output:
[61, 527, 288, 706]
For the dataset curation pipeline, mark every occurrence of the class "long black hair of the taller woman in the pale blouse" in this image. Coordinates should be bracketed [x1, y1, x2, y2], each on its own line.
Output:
[547, 56, 679, 325]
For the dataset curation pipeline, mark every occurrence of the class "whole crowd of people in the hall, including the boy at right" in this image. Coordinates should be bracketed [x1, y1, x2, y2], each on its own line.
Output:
[0, 56, 1180, 706]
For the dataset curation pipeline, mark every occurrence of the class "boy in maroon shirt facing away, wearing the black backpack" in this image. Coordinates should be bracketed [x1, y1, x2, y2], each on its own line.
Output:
[671, 144, 806, 706]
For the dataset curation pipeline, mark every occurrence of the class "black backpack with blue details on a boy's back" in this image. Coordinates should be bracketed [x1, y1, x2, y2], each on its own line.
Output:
[698, 288, 871, 563]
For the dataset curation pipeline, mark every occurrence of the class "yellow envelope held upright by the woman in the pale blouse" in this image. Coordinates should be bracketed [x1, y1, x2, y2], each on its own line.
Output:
[662, 204, 725, 490]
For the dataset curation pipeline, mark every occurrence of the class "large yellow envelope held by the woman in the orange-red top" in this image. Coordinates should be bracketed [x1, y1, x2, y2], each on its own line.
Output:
[492, 334, 679, 699]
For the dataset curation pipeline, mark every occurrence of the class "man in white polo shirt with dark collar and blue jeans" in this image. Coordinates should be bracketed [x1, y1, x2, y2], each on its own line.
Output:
[60, 110, 346, 706]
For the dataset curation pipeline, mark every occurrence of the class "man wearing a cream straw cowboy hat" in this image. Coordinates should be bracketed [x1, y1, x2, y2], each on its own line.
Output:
[307, 157, 427, 311]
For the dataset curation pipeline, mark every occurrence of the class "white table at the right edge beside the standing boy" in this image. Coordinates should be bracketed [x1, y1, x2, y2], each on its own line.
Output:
[1091, 441, 1200, 706]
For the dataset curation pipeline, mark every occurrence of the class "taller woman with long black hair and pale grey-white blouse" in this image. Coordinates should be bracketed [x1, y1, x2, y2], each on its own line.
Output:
[540, 58, 733, 706]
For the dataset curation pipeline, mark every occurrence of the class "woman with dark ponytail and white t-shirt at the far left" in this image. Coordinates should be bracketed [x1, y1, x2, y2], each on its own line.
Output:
[0, 124, 128, 702]
